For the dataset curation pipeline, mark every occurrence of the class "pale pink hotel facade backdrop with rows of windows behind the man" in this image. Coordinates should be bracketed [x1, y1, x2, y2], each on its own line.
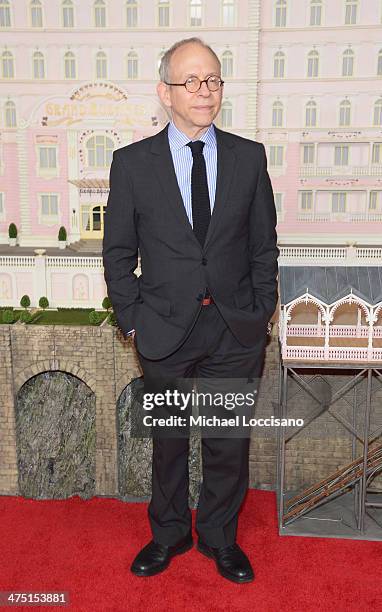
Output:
[0, 0, 382, 307]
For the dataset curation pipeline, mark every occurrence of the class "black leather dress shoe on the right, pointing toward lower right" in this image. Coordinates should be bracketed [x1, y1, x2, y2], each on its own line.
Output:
[197, 540, 255, 583]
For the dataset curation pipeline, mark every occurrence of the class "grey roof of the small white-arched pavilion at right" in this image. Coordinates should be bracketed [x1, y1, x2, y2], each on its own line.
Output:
[279, 266, 382, 304]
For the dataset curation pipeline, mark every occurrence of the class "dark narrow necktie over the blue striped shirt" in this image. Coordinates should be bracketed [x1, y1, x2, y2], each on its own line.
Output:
[187, 140, 211, 246]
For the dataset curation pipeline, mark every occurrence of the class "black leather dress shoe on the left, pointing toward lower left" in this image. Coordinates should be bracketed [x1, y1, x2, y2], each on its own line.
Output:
[130, 532, 193, 576]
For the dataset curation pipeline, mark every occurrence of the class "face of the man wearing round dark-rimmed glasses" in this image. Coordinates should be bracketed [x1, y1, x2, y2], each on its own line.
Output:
[157, 43, 223, 136]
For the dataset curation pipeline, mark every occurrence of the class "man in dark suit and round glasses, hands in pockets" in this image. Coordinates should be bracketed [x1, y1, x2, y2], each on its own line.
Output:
[103, 38, 279, 583]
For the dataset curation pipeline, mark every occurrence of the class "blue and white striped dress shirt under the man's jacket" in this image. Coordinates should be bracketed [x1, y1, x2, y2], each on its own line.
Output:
[168, 121, 217, 225]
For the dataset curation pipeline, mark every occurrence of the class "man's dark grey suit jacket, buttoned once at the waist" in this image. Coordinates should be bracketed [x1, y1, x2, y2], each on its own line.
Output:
[103, 124, 279, 359]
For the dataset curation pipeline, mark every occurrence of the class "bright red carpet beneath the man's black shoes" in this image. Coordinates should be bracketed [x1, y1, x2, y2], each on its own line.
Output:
[0, 490, 382, 612]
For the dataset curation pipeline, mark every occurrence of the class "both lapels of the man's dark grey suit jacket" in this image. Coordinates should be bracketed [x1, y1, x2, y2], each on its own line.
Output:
[151, 124, 236, 249]
